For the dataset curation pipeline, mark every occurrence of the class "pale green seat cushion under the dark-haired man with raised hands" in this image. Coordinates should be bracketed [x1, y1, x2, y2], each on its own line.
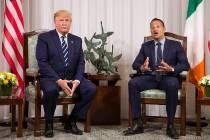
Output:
[141, 89, 181, 99]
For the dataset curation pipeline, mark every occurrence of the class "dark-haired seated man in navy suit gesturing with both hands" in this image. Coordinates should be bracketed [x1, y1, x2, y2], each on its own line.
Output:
[124, 18, 190, 139]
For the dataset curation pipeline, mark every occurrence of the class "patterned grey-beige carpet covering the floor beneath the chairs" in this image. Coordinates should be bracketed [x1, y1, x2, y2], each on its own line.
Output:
[0, 121, 210, 140]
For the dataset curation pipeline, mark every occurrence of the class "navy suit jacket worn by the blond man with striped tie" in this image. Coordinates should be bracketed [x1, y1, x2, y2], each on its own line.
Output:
[36, 30, 85, 81]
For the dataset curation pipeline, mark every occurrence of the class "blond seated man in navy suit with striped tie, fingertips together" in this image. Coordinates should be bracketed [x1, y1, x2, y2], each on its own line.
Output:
[36, 10, 96, 137]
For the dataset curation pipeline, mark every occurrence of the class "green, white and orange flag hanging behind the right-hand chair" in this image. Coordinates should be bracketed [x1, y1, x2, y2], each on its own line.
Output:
[185, 0, 205, 97]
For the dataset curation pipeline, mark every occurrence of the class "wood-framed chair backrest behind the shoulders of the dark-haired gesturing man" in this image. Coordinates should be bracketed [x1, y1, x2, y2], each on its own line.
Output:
[144, 32, 187, 53]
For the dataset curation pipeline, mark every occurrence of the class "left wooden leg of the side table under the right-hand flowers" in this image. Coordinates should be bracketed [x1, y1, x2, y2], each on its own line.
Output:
[196, 99, 202, 136]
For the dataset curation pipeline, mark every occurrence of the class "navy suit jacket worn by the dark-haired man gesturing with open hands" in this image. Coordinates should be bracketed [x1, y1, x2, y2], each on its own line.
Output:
[132, 39, 190, 76]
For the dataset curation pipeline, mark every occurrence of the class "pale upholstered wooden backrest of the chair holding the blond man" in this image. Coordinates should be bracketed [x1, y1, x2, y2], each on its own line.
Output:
[23, 30, 47, 72]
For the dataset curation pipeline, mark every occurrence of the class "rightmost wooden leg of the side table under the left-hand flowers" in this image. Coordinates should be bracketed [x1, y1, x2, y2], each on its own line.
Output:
[17, 100, 23, 137]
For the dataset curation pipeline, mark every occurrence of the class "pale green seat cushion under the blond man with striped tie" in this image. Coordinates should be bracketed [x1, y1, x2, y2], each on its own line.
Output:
[25, 85, 72, 98]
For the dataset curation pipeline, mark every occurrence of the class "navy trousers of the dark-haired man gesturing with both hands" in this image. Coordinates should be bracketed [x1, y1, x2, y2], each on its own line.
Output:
[128, 75, 179, 123]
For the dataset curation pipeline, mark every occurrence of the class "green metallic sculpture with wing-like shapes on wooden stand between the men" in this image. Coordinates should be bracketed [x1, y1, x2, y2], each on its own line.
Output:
[84, 22, 122, 74]
